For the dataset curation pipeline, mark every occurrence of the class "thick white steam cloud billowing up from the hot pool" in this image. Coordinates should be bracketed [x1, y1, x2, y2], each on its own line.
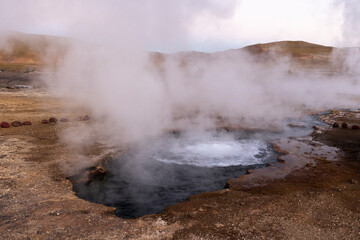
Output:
[0, 0, 360, 145]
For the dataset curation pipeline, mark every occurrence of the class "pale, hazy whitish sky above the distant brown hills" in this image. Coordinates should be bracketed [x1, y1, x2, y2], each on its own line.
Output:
[0, 0, 358, 52]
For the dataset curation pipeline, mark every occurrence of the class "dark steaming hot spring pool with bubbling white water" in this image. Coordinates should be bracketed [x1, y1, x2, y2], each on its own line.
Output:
[74, 131, 277, 218]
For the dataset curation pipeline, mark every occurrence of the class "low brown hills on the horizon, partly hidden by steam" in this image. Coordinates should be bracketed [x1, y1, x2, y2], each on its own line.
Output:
[0, 32, 346, 73]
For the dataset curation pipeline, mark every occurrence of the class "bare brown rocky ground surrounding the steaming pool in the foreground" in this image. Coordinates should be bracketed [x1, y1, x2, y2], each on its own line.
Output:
[0, 73, 360, 239]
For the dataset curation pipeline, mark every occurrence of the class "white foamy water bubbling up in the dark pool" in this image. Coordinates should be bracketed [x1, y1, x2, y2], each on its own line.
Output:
[154, 138, 268, 167]
